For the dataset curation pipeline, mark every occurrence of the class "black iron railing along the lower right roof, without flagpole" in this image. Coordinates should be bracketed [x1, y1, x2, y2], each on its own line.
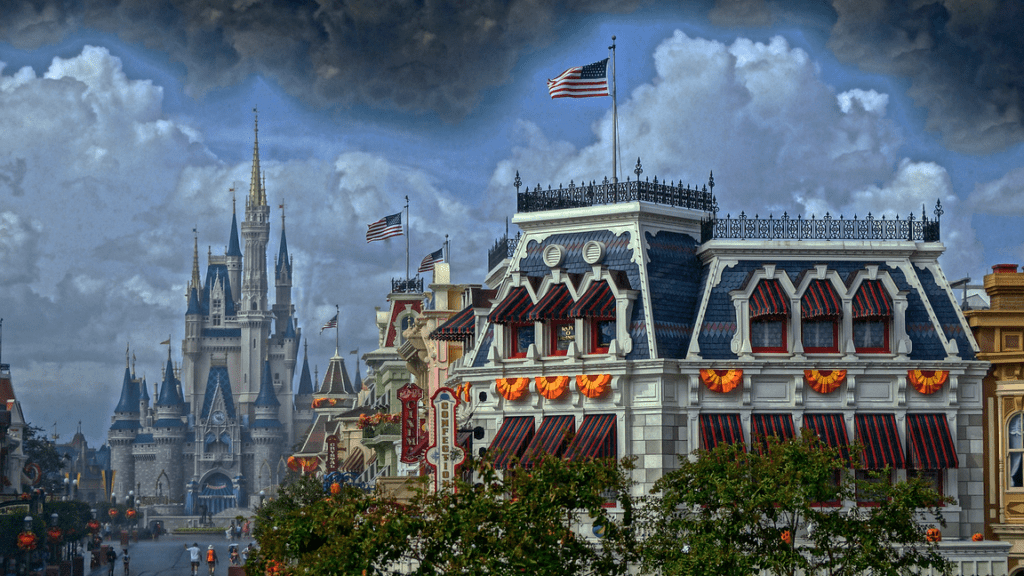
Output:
[700, 202, 943, 242]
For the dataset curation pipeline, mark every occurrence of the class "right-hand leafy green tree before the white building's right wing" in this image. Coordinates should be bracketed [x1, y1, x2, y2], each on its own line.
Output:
[641, 430, 949, 576]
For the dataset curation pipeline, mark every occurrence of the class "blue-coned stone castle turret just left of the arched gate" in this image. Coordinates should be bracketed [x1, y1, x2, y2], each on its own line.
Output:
[153, 345, 187, 502]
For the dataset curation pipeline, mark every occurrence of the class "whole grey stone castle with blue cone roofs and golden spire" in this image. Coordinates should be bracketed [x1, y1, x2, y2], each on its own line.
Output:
[109, 115, 312, 515]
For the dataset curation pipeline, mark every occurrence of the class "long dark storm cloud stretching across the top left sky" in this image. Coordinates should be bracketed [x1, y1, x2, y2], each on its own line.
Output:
[0, 0, 640, 120]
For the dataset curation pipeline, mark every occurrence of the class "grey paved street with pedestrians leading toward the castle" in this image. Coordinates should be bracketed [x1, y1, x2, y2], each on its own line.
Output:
[89, 535, 251, 576]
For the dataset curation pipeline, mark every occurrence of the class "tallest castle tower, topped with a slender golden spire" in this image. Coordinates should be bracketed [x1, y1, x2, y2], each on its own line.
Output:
[237, 111, 271, 407]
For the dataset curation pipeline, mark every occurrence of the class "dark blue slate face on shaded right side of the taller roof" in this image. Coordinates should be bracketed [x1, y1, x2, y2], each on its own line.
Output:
[636, 231, 702, 358]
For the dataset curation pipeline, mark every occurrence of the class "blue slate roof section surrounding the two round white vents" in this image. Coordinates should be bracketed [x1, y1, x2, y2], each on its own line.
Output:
[520, 230, 650, 360]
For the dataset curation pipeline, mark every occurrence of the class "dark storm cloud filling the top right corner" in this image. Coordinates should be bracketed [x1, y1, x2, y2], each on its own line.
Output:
[828, 0, 1024, 154]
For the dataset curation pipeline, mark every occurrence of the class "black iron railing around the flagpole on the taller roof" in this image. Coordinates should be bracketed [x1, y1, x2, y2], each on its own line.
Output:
[513, 158, 718, 214]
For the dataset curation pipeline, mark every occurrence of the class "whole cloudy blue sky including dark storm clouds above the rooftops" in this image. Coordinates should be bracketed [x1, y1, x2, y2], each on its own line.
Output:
[0, 0, 1024, 445]
